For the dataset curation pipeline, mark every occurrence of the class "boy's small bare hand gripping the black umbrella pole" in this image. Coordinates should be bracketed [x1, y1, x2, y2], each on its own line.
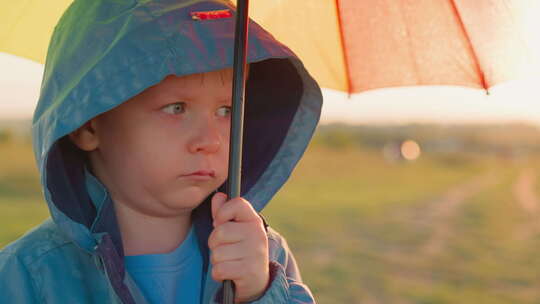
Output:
[208, 192, 270, 303]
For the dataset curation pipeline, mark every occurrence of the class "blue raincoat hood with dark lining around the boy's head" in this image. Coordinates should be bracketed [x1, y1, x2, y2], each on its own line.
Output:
[32, 0, 322, 256]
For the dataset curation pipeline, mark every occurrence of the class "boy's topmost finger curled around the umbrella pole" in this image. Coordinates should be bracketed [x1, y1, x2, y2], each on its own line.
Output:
[214, 197, 261, 227]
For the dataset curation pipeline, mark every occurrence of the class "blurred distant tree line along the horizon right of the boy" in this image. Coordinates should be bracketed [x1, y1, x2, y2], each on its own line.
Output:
[313, 123, 540, 156]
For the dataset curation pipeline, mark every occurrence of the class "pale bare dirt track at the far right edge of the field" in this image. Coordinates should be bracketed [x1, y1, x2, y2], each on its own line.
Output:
[512, 168, 540, 240]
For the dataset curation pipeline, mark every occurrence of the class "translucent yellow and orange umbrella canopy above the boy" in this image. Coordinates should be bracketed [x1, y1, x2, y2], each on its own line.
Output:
[4, 0, 540, 93]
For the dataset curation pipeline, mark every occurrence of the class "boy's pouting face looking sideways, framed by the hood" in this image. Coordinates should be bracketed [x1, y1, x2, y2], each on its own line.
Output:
[79, 69, 232, 217]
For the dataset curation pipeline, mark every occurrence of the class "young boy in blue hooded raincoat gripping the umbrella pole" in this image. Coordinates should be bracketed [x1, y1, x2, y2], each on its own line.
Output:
[0, 0, 322, 304]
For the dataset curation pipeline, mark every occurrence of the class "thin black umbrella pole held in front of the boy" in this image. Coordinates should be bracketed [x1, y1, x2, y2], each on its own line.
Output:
[223, 0, 249, 304]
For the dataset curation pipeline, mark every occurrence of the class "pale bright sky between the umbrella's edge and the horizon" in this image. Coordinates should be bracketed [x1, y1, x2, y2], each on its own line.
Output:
[0, 52, 540, 126]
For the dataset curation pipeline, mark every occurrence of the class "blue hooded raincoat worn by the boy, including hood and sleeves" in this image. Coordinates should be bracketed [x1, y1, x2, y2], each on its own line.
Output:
[0, 0, 322, 304]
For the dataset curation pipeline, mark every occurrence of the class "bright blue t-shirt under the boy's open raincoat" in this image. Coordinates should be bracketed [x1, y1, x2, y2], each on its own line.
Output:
[85, 170, 203, 304]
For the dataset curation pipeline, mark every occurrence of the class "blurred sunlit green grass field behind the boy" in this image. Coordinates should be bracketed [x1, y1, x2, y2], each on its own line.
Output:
[0, 144, 540, 304]
